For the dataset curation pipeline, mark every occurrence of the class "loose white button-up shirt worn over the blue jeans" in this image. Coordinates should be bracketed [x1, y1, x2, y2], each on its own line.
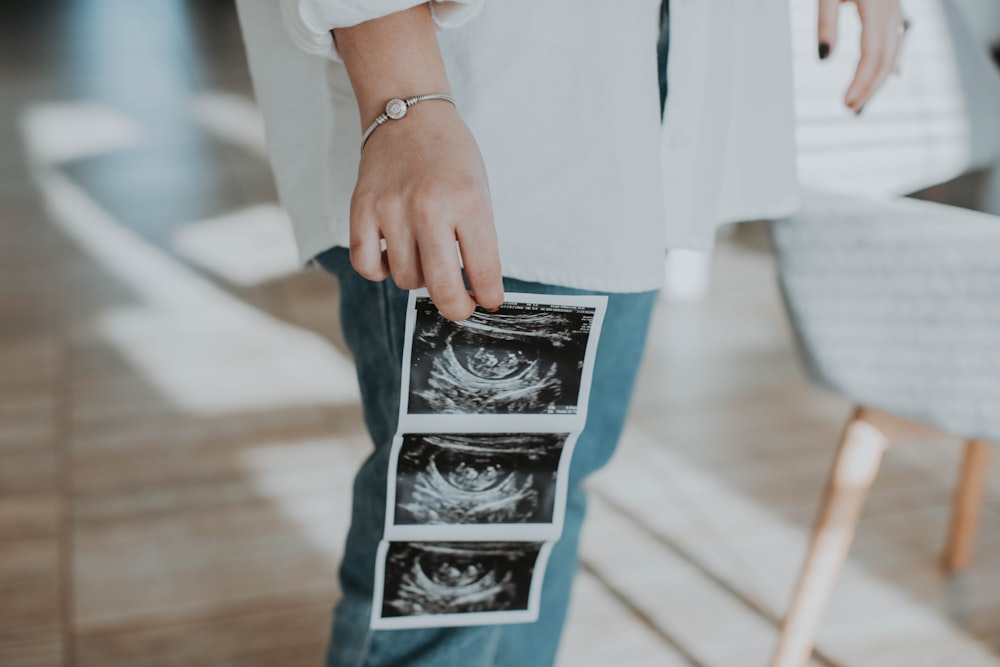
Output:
[239, 0, 795, 292]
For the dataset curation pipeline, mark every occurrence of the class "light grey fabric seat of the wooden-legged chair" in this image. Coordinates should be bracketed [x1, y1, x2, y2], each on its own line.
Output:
[772, 193, 1000, 443]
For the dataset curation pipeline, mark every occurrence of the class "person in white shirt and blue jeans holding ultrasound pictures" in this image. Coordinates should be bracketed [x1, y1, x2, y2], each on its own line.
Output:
[238, 0, 916, 667]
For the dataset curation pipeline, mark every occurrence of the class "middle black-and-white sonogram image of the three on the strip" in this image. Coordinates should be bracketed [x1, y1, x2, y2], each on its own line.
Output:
[395, 433, 569, 524]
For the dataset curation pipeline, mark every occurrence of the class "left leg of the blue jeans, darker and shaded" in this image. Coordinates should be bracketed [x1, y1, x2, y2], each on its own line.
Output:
[317, 248, 499, 667]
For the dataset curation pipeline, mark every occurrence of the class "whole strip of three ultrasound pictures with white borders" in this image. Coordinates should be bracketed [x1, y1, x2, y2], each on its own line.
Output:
[371, 290, 607, 629]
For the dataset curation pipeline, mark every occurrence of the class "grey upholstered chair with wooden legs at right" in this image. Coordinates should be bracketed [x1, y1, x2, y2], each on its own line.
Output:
[772, 193, 1000, 667]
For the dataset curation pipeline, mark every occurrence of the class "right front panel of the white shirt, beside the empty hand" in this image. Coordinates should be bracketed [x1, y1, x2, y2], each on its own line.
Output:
[662, 0, 800, 250]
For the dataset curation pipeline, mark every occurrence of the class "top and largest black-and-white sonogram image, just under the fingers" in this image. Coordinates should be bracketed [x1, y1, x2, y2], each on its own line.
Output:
[408, 297, 595, 414]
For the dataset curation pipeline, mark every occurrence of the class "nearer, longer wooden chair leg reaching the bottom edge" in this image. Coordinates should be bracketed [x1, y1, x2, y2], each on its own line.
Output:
[771, 408, 889, 667]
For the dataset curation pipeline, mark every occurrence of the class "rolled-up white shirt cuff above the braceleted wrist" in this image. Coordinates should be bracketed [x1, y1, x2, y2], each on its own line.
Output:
[280, 0, 485, 60]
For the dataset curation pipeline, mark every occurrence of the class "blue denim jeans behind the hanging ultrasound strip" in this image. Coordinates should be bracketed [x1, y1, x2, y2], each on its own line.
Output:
[317, 248, 656, 667]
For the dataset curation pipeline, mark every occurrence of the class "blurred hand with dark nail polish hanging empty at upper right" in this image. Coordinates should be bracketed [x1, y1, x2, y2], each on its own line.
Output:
[819, 0, 907, 113]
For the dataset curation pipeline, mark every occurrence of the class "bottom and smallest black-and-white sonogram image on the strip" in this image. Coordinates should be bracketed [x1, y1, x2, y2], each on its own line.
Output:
[382, 542, 542, 618]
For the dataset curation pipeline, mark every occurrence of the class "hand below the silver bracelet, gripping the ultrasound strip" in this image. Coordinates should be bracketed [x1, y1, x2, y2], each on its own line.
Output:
[351, 100, 503, 320]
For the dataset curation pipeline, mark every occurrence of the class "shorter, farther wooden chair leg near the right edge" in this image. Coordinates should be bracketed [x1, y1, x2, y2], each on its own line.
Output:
[941, 440, 991, 574]
